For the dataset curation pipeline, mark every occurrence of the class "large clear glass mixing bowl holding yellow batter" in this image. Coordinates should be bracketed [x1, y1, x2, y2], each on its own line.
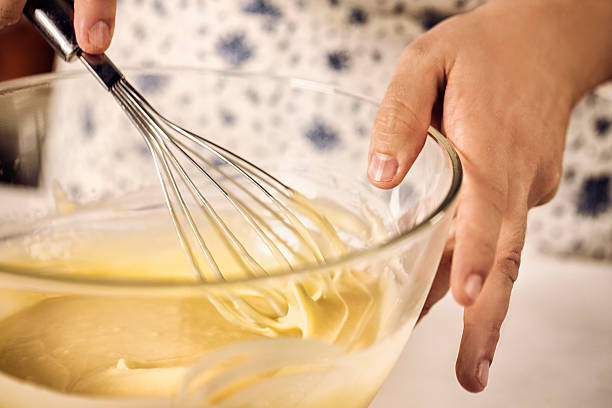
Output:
[0, 68, 461, 408]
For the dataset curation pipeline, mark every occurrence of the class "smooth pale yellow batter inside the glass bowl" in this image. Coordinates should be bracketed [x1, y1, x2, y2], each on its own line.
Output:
[0, 190, 412, 407]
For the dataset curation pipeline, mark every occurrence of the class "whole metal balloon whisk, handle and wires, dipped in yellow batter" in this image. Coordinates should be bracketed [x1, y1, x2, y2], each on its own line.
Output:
[24, 0, 343, 332]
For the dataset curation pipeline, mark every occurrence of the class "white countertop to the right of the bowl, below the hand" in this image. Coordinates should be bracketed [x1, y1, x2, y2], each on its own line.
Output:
[370, 250, 612, 408]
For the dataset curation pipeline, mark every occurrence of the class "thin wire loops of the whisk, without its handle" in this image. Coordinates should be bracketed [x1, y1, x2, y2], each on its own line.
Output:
[110, 78, 340, 281]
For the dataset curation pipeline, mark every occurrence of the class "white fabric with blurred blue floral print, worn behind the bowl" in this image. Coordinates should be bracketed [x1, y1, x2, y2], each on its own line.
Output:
[53, 0, 612, 260]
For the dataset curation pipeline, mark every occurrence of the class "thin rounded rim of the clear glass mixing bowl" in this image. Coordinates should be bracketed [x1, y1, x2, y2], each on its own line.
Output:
[0, 65, 463, 296]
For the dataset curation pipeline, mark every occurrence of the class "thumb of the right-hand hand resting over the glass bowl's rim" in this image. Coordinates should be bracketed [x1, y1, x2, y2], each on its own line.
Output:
[368, 41, 444, 188]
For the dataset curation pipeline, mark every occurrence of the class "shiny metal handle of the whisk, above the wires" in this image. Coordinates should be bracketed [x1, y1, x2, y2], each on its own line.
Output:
[23, 0, 123, 91]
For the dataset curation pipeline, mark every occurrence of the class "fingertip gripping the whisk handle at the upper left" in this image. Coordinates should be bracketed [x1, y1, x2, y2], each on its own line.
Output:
[74, 0, 117, 54]
